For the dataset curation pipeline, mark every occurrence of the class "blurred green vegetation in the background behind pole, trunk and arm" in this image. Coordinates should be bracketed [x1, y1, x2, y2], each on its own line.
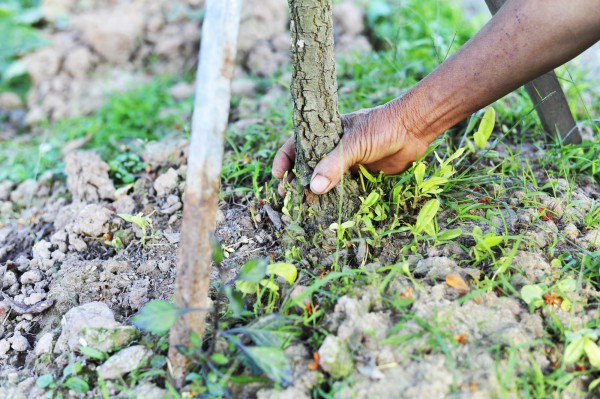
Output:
[0, 0, 600, 184]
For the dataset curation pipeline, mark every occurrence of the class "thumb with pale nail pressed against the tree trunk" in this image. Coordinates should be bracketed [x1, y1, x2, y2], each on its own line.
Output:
[310, 136, 354, 194]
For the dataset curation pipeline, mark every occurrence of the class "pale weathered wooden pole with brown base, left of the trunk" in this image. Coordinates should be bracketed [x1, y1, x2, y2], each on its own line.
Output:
[169, 0, 242, 387]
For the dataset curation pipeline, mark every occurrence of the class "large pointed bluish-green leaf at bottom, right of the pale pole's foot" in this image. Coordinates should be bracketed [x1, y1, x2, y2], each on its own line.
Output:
[242, 346, 294, 386]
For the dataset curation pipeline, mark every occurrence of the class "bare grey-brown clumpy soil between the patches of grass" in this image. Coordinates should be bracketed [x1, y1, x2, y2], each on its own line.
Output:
[0, 0, 600, 398]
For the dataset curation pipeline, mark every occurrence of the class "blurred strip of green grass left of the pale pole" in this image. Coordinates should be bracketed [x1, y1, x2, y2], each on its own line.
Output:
[0, 79, 192, 183]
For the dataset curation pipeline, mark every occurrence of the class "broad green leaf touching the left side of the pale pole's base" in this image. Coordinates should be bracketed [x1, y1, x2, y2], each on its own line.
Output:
[131, 300, 185, 335]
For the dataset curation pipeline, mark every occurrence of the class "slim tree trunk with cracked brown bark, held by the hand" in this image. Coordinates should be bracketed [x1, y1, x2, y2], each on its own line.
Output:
[289, 0, 358, 229]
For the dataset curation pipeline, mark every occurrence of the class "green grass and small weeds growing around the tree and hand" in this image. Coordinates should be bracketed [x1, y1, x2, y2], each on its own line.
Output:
[9, 0, 600, 398]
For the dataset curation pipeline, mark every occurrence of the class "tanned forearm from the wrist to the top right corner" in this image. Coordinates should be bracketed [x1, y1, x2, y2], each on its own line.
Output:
[389, 0, 600, 142]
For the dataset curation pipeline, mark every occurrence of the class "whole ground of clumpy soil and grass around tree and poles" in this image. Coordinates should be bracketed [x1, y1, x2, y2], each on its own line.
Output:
[0, 0, 600, 398]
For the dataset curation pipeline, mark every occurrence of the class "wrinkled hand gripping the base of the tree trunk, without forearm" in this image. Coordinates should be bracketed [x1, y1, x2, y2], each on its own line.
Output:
[272, 103, 429, 194]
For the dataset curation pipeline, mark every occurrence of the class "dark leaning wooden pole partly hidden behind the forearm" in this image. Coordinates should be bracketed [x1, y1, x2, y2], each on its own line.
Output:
[485, 0, 581, 144]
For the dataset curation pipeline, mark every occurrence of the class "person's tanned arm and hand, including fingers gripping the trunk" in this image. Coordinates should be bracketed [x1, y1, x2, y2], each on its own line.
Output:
[272, 0, 600, 194]
